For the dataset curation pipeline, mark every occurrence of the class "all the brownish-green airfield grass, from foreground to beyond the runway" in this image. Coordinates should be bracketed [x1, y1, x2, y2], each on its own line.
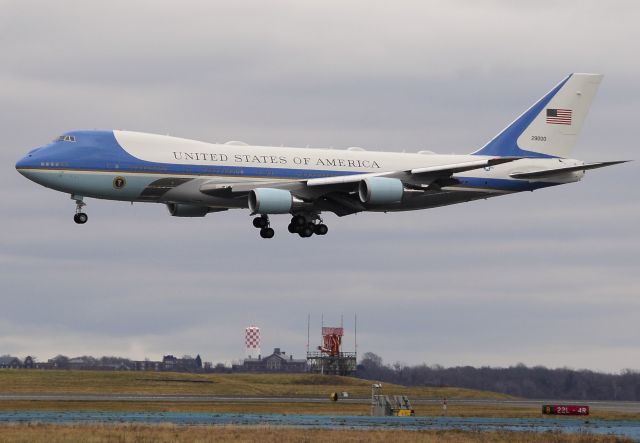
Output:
[0, 370, 640, 443]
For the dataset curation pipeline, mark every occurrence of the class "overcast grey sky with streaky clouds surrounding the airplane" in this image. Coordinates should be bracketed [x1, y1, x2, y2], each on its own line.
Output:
[0, 0, 640, 372]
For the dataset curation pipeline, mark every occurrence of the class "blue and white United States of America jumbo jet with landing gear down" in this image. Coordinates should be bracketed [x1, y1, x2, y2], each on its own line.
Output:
[16, 74, 622, 238]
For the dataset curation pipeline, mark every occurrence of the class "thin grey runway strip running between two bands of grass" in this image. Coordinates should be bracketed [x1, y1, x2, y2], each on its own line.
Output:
[0, 394, 640, 413]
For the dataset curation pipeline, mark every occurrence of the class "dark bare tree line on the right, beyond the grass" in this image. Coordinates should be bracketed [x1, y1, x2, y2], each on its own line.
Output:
[356, 352, 640, 401]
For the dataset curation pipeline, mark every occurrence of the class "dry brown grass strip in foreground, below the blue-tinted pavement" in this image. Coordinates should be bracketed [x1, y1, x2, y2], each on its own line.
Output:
[0, 424, 631, 443]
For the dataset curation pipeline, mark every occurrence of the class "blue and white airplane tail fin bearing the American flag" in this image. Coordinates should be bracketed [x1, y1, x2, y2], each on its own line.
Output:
[473, 74, 603, 157]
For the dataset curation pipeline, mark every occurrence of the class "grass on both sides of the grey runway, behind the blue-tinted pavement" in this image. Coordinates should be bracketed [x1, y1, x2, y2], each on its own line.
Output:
[0, 369, 640, 420]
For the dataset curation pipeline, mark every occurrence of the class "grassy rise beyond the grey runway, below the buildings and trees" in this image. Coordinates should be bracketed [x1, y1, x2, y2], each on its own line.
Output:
[0, 369, 512, 399]
